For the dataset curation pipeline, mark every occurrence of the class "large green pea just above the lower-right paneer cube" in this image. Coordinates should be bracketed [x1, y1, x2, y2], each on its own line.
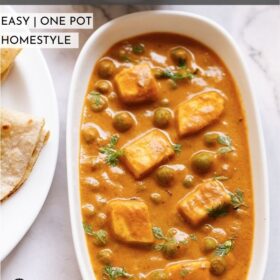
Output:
[191, 151, 215, 174]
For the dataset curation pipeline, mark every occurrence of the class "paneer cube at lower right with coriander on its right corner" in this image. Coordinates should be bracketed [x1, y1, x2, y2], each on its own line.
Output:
[177, 180, 231, 225]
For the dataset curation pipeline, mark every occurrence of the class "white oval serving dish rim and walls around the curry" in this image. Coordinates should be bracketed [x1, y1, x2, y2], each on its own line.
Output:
[66, 11, 269, 280]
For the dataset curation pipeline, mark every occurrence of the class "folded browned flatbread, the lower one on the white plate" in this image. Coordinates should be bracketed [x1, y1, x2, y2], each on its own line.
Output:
[0, 109, 49, 201]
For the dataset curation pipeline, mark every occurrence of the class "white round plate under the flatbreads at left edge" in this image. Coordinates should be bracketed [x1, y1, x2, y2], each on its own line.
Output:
[0, 6, 59, 261]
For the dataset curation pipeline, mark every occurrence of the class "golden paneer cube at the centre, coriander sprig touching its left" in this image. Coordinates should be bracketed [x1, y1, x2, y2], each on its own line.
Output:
[122, 129, 174, 179]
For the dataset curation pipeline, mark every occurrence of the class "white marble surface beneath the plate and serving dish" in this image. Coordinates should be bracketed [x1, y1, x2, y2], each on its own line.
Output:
[1, 5, 280, 280]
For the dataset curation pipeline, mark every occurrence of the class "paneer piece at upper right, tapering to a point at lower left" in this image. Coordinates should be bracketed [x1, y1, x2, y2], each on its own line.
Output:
[176, 91, 225, 136]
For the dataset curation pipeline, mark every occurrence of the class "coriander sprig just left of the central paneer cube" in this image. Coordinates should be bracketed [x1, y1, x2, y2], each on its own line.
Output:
[99, 135, 123, 167]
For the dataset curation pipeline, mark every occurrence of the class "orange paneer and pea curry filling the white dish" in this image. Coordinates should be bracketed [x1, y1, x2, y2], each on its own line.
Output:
[80, 33, 254, 280]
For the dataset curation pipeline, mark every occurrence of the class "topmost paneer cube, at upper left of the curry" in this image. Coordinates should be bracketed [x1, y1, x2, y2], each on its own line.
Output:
[115, 63, 158, 104]
